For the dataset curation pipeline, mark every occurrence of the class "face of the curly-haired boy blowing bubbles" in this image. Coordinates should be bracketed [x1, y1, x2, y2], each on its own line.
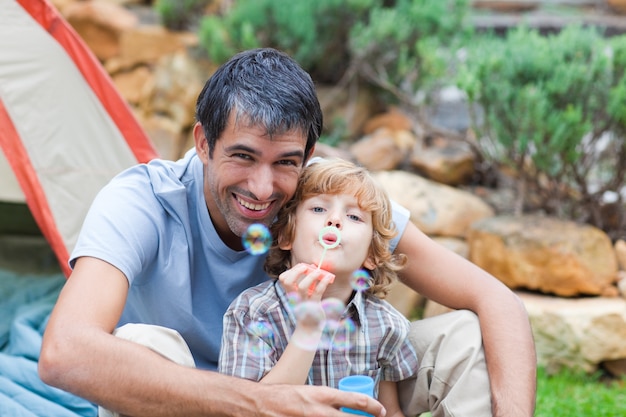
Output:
[282, 194, 374, 276]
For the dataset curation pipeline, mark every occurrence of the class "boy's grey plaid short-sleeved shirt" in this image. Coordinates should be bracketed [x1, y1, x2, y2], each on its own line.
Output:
[219, 280, 418, 388]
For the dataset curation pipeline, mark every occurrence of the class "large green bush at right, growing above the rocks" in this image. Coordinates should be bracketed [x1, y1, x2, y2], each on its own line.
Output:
[458, 26, 626, 231]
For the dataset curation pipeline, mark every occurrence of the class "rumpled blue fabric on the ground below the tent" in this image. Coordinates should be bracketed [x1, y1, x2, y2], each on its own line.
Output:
[0, 269, 97, 417]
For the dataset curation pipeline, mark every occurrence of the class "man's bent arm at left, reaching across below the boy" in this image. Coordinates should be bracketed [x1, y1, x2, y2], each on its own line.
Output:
[39, 258, 384, 417]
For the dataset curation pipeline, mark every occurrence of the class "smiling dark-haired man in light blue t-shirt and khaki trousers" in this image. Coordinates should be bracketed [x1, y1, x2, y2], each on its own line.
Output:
[39, 49, 535, 417]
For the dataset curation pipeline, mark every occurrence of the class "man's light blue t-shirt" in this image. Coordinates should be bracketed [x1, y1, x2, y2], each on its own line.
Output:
[70, 149, 409, 369]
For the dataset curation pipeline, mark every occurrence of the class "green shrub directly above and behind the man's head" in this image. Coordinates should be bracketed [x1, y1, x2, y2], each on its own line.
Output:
[199, 0, 383, 82]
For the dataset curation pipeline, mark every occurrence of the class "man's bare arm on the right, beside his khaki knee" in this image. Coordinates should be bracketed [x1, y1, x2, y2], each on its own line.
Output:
[397, 223, 537, 417]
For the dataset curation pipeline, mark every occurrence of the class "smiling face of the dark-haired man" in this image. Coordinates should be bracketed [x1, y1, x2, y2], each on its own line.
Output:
[194, 115, 306, 250]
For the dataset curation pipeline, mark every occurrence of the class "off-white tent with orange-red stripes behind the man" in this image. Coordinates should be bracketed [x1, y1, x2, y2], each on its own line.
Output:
[0, 0, 157, 276]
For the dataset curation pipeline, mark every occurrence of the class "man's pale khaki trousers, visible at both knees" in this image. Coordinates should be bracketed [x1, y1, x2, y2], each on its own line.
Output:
[98, 310, 491, 417]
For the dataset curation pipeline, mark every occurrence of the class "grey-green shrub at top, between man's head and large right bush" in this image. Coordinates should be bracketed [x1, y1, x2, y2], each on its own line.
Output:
[349, 0, 473, 110]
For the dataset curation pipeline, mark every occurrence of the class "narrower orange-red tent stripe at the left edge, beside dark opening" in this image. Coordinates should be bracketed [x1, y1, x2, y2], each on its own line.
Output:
[0, 100, 70, 277]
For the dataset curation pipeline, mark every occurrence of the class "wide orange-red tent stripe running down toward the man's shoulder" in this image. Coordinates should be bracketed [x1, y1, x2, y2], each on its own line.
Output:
[17, 0, 158, 162]
